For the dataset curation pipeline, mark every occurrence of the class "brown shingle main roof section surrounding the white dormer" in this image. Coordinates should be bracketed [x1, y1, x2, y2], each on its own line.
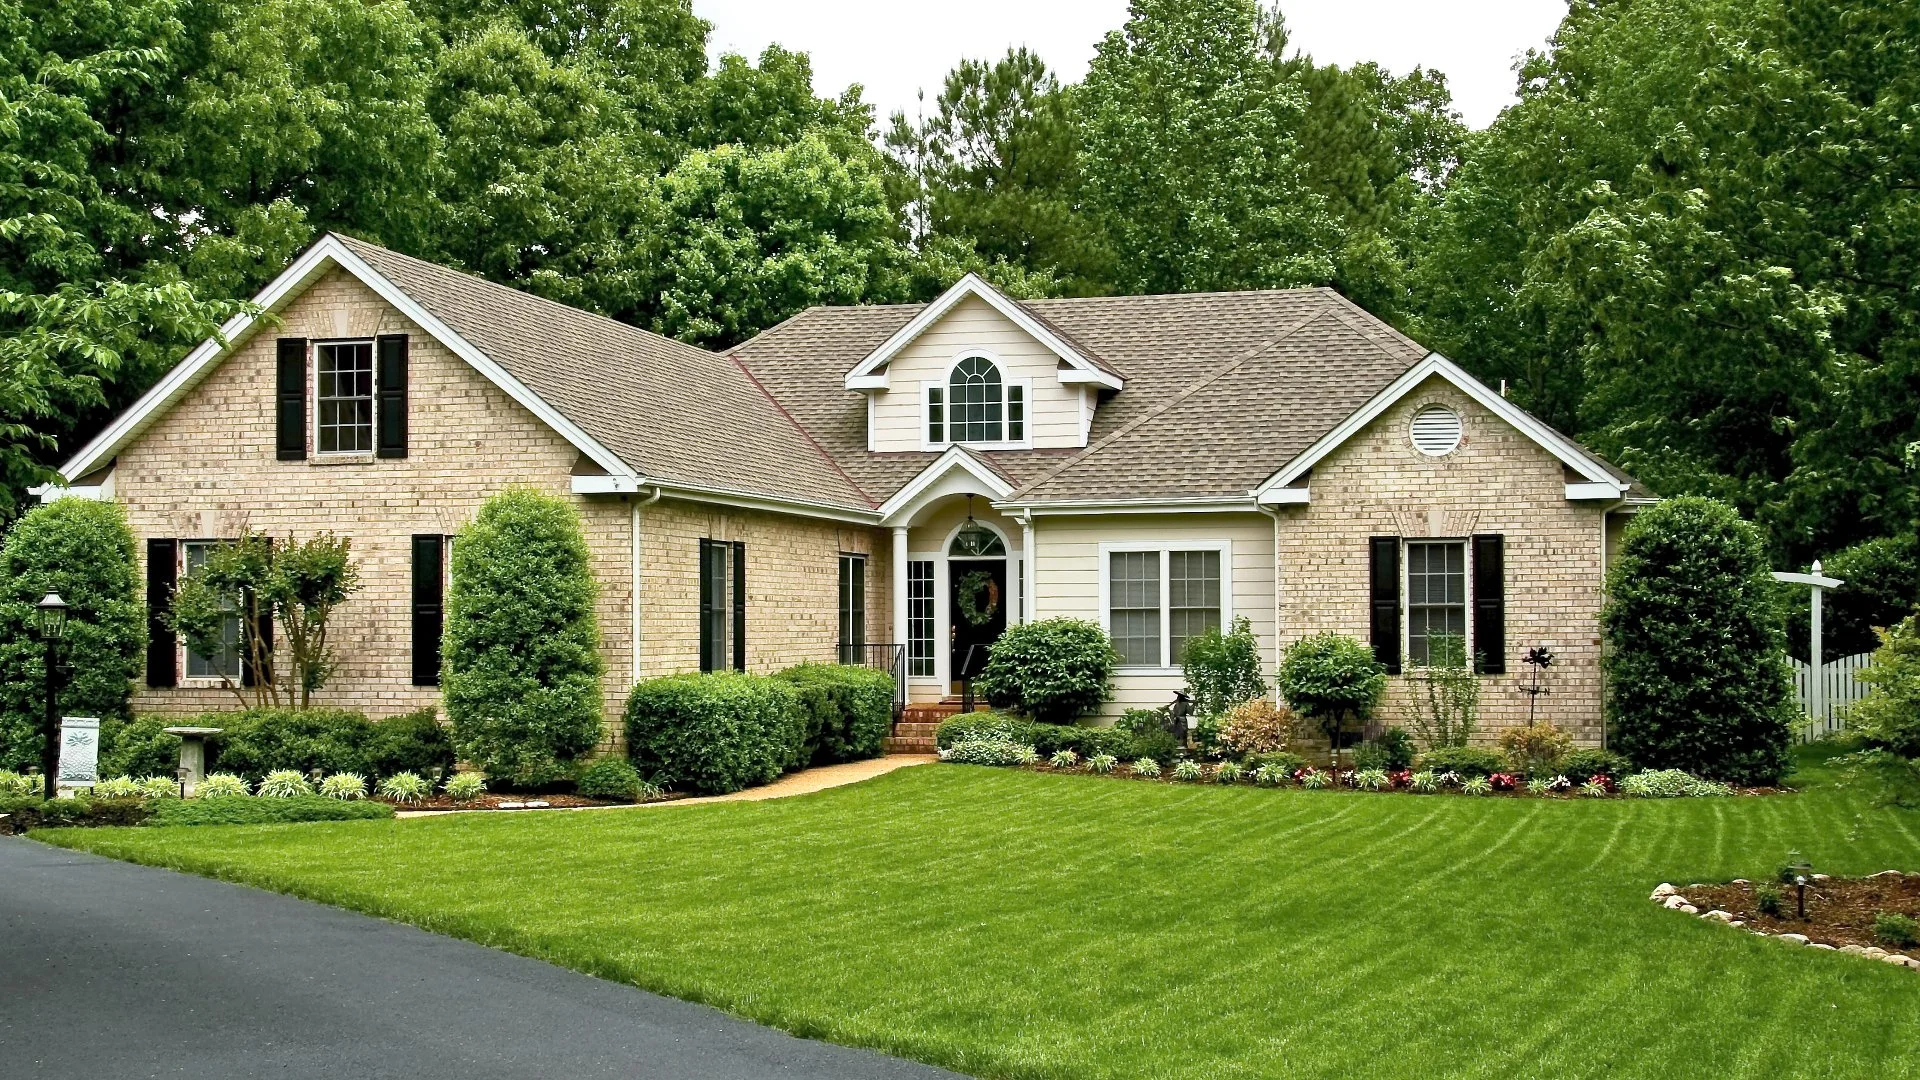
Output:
[733, 288, 1427, 502]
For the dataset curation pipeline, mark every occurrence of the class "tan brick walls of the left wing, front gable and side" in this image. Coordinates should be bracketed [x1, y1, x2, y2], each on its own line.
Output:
[113, 271, 889, 746]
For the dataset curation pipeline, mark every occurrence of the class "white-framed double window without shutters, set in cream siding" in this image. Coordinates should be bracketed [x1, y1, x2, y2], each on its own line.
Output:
[1100, 540, 1233, 669]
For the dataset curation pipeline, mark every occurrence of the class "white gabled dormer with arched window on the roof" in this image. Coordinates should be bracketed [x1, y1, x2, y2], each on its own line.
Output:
[847, 275, 1125, 452]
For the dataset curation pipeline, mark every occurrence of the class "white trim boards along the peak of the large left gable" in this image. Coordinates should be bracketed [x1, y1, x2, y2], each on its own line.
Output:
[48, 233, 637, 490]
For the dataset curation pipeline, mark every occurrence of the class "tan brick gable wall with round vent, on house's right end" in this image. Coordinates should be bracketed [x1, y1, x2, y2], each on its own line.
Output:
[1279, 379, 1603, 746]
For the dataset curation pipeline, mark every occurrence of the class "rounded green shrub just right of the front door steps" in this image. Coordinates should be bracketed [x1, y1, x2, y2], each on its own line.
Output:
[973, 619, 1119, 724]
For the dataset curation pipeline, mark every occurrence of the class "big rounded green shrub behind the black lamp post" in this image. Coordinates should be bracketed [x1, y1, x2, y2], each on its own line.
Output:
[0, 498, 146, 769]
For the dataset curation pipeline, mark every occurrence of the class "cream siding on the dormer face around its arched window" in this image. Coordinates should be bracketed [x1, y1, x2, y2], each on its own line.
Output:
[870, 296, 1085, 450]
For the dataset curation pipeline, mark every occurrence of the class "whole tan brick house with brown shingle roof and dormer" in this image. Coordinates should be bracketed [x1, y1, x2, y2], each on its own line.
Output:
[42, 234, 1647, 742]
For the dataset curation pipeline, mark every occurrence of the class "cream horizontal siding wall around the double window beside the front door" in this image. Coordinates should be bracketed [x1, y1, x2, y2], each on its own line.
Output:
[1033, 513, 1275, 717]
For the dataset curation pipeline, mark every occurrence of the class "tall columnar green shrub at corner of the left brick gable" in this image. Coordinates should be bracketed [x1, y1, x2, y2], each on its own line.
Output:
[442, 488, 601, 786]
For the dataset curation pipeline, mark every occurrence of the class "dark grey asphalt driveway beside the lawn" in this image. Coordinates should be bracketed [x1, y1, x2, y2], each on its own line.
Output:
[0, 838, 956, 1080]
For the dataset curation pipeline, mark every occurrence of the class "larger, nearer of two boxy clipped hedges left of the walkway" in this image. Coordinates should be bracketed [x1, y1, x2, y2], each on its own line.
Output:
[626, 671, 806, 796]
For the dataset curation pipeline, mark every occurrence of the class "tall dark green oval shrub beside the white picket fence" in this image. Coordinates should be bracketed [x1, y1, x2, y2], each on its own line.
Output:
[1601, 496, 1797, 784]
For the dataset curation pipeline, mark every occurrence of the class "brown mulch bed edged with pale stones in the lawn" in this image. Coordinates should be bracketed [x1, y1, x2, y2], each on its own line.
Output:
[1651, 871, 1920, 970]
